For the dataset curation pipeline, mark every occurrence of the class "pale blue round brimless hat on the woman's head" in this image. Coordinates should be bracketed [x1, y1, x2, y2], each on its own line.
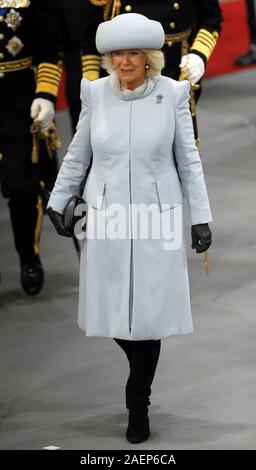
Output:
[96, 13, 165, 54]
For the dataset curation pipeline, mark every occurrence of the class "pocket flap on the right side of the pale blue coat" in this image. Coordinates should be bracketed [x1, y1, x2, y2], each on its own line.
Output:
[155, 173, 183, 212]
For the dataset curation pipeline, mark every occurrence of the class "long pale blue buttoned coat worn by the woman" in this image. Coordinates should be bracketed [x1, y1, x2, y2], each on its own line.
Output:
[48, 76, 212, 340]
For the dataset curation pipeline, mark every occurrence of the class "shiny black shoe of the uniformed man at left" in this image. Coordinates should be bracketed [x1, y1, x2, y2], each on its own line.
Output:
[21, 256, 44, 295]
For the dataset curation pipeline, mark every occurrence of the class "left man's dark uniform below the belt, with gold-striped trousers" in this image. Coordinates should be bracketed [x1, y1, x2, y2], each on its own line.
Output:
[0, 69, 58, 263]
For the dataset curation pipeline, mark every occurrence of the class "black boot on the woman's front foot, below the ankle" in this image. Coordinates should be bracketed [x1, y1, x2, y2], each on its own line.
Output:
[126, 410, 150, 444]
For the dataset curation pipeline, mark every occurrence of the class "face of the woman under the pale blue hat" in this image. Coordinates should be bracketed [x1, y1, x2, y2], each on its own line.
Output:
[112, 49, 146, 90]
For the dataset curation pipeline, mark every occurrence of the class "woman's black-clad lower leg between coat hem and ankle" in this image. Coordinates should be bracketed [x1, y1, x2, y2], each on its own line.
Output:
[113, 338, 161, 411]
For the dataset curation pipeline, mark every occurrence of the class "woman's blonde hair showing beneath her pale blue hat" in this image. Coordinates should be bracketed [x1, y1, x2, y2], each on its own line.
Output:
[102, 49, 165, 77]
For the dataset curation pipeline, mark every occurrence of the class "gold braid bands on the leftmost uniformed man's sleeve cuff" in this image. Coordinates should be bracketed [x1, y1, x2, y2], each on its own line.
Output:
[36, 60, 63, 97]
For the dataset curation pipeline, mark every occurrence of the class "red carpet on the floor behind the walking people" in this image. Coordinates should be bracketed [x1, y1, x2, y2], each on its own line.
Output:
[57, 0, 255, 110]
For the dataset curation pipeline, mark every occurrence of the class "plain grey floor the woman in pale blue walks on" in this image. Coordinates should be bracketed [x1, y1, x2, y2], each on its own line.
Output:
[0, 70, 256, 450]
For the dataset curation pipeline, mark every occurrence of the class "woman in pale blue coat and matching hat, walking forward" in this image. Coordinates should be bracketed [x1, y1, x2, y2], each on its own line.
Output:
[48, 13, 212, 443]
